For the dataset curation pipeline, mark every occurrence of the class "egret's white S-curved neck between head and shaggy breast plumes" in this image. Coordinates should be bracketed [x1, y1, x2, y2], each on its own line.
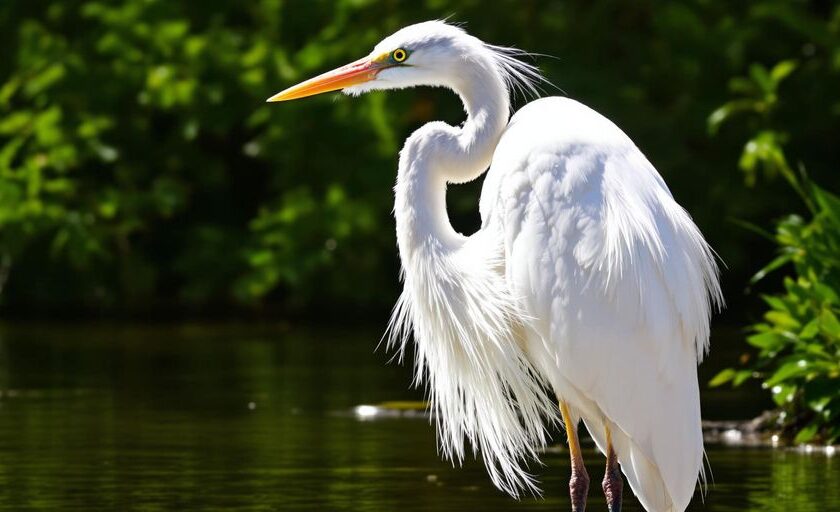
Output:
[394, 61, 510, 260]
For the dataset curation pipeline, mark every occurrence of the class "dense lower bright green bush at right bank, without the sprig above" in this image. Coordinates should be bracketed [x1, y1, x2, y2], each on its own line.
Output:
[710, 180, 840, 443]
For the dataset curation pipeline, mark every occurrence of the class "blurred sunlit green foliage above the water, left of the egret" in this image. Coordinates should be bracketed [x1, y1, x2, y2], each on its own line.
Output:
[0, 0, 396, 307]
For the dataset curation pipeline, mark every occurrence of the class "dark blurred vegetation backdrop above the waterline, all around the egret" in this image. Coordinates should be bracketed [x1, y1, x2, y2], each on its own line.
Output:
[0, 0, 840, 322]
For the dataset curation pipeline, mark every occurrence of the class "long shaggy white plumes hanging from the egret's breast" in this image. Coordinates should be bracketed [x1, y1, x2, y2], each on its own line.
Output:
[389, 228, 555, 495]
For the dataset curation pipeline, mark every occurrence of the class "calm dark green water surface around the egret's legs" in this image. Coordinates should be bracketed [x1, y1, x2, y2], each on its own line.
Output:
[0, 326, 840, 512]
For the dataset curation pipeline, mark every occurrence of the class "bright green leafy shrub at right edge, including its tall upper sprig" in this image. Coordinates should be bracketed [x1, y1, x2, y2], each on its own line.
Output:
[709, 48, 840, 443]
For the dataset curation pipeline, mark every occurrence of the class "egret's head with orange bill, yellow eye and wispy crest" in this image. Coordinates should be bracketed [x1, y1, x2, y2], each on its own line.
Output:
[268, 21, 541, 101]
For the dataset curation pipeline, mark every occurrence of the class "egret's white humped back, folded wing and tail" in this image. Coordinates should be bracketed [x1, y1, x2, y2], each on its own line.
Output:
[481, 98, 721, 510]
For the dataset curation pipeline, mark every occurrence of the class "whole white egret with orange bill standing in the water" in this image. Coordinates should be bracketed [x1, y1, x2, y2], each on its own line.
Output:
[268, 21, 722, 512]
